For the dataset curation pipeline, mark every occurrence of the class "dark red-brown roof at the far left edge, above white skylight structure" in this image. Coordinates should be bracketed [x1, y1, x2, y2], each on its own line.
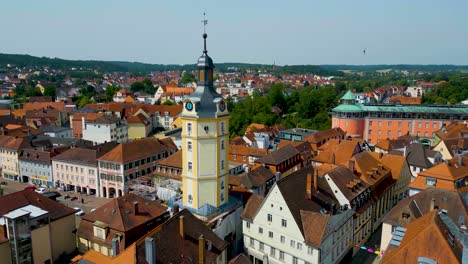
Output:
[0, 190, 76, 221]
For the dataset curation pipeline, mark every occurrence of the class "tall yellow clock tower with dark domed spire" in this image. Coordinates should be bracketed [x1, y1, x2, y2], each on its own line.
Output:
[180, 33, 229, 211]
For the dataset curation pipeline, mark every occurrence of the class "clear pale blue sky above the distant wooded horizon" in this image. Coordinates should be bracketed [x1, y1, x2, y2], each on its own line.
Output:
[0, 0, 468, 65]
